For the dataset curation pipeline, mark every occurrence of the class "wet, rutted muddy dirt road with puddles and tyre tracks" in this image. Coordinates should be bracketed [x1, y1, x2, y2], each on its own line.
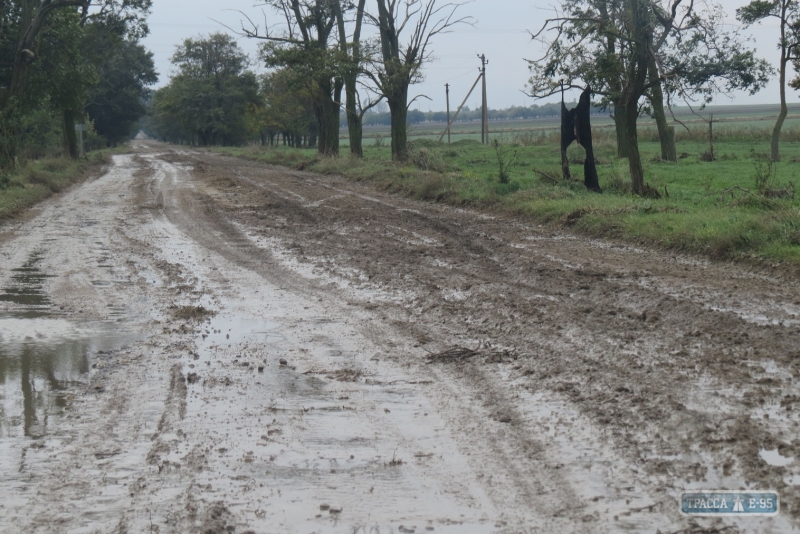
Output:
[0, 142, 800, 534]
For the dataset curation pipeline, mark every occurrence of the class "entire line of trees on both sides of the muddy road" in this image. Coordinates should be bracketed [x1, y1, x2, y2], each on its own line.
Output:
[7, 0, 800, 199]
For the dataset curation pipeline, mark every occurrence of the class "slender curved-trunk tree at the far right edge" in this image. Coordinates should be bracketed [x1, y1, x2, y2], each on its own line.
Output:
[736, 0, 800, 162]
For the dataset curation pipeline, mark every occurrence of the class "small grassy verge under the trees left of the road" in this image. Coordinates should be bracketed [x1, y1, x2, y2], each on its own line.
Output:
[0, 149, 119, 220]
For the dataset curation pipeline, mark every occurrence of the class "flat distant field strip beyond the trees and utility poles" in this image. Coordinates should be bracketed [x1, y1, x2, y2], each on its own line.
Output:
[340, 100, 800, 146]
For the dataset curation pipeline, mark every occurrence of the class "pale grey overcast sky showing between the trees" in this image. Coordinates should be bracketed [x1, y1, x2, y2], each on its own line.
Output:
[144, 0, 800, 111]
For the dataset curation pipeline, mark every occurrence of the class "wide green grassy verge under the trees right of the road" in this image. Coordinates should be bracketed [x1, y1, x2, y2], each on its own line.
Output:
[211, 134, 800, 264]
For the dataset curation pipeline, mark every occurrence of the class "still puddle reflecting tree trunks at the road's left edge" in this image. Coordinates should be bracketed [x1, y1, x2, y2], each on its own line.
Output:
[0, 314, 134, 441]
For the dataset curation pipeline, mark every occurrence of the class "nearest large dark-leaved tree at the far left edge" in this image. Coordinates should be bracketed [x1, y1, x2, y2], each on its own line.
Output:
[0, 0, 151, 166]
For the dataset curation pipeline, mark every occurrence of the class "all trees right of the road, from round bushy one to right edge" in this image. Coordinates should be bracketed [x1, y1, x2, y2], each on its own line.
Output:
[147, 0, 800, 194]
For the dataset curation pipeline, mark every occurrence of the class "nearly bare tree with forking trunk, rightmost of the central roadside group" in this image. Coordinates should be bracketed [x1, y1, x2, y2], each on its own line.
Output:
[369, 0, 469, 160]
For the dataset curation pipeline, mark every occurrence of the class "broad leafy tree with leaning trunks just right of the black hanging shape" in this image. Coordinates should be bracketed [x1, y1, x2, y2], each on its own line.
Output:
[528, 0, 769, 194]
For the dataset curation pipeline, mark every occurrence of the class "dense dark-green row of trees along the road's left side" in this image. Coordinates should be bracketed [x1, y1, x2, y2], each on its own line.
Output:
[0, 0, 157, 170]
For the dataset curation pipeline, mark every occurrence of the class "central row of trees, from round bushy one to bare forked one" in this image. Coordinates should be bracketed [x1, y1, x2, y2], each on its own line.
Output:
[148, 0, 465, 159]
